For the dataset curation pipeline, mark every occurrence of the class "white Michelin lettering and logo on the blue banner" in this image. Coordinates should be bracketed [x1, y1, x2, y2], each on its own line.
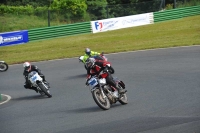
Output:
[0, 35, 23, 44]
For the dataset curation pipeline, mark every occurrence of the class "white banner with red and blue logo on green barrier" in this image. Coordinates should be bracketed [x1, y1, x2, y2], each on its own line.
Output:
[91, 13, 153, 33]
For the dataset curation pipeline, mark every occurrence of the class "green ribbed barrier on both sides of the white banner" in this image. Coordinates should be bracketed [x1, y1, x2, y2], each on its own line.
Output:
[28, 5, 200, 41]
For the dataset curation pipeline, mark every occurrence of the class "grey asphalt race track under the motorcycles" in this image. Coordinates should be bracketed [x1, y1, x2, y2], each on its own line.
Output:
[0, 46, 200, 133]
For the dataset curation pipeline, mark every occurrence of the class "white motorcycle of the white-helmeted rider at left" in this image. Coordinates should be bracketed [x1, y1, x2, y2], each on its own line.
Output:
[28, 71, 52, 98]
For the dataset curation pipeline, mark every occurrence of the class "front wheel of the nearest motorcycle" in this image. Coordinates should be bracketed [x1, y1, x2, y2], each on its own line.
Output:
[92, 89, 110, 110]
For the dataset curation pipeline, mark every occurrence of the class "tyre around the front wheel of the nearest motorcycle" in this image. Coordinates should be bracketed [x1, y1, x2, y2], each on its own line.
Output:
[92, 89, 110, 110]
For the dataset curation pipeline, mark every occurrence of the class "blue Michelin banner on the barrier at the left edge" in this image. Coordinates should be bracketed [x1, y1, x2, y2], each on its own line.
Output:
[0, 30, 28, 46]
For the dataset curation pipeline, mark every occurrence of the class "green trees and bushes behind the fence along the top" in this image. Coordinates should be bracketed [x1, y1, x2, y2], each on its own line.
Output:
[0, 0, 195, 25]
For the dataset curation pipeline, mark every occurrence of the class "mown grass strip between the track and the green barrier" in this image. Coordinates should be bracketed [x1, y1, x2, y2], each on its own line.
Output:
[0, 15, 200, 64]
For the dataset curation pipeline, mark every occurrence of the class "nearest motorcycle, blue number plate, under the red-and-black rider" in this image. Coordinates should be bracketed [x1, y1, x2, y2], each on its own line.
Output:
[87, 73, 128, 110]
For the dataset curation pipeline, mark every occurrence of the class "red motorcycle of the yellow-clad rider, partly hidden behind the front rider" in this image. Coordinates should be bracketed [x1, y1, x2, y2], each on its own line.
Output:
[79, 54, 115, 74]
